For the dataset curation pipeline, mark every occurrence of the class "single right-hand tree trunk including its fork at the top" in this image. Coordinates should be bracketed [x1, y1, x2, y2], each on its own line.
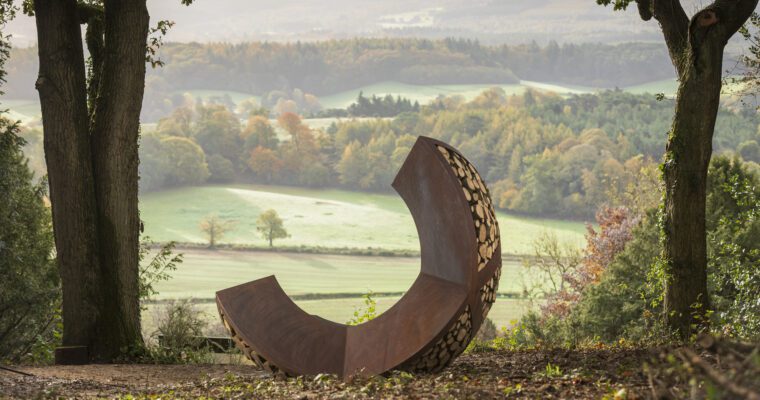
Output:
[637, 0, 758, 338]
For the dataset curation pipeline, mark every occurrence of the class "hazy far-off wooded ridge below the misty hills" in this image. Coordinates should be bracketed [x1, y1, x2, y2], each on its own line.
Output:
[6, 38, 674, 122]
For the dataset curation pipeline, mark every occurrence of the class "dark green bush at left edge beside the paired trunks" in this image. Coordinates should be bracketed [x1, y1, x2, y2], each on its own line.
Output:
[0, 118, 61, 363]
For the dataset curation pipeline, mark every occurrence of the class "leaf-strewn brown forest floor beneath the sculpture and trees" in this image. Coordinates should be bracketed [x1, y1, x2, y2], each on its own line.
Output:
[0, 340, 760, 400]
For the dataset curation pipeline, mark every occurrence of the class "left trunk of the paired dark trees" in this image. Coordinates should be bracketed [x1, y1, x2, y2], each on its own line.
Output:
[34, 0, 101, 345]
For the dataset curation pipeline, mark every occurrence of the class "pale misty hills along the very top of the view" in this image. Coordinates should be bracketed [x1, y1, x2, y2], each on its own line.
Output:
[2, 0, 732, 46]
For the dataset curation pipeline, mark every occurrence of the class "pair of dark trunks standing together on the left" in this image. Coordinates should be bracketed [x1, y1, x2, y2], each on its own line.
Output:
[34, 0, 149, 361]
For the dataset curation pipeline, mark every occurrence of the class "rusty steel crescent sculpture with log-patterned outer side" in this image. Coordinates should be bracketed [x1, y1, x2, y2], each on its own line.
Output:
[216, 137, 501, 377]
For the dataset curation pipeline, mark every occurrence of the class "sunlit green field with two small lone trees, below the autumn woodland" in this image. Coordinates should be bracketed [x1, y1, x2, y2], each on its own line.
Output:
[140, 185, 585, 254]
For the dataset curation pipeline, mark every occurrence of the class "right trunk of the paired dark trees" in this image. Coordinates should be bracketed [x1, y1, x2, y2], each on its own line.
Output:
[91, 0, 149, 360]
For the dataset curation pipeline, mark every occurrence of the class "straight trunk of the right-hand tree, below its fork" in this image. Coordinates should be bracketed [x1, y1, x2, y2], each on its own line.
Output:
[663, 46, 723, 338]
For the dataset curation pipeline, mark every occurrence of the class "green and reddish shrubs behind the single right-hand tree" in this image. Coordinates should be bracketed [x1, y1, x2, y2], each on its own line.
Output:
[504, 156, 760, 348]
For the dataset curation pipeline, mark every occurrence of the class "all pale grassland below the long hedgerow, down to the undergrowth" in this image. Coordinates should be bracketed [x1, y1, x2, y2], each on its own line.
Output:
[144, 250, 536, 334]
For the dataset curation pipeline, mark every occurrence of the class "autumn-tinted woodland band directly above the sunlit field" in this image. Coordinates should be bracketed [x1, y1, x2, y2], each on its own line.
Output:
[119, 88, 760, 218]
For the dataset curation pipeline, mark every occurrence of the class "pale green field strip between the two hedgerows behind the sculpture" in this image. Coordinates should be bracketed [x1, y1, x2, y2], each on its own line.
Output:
[145, 250, 536, 300]
